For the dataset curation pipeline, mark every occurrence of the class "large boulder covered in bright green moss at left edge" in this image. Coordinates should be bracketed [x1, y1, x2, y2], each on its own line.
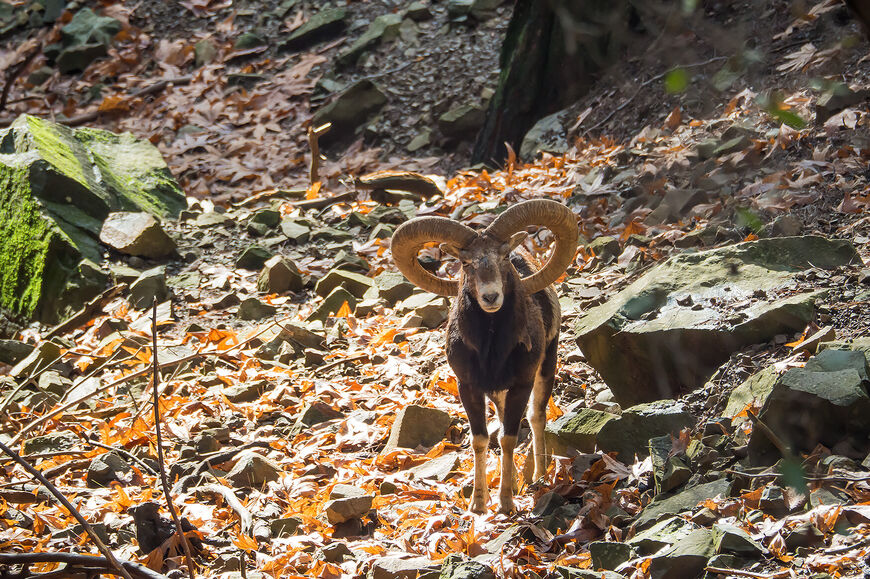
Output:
[0, 115, 185, 333]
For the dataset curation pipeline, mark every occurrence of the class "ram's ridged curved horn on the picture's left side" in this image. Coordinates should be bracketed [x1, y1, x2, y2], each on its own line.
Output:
[390, 217, 477, 296]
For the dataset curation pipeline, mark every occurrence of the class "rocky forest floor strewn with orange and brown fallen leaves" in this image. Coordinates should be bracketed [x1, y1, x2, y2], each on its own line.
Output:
[0, 0, 870, 578]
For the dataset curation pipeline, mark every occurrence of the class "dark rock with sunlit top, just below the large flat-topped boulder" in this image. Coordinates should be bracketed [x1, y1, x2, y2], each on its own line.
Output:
[597, 400, 694, 463]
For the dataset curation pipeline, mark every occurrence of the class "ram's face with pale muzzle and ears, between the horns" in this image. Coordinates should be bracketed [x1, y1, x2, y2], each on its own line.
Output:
[442, 233, 526, 313]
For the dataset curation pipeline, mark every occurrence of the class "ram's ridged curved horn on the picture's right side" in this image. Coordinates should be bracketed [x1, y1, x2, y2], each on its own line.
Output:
[484, 199, 578, 294]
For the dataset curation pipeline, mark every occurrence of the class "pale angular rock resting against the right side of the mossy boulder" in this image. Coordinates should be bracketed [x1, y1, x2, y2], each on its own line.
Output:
[100, 211, 175, 259]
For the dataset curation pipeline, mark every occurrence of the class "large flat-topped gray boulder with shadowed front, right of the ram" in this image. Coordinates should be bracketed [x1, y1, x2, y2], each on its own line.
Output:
[575, 236, 860, 406]
